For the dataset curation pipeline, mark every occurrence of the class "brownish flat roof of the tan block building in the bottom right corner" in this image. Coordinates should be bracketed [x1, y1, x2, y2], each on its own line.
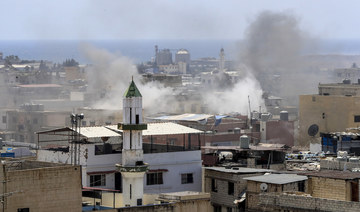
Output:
[301, 170, 360, 180]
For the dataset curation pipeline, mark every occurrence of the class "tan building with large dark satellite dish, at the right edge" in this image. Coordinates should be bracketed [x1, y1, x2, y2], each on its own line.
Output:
[295, 80, 360, 147]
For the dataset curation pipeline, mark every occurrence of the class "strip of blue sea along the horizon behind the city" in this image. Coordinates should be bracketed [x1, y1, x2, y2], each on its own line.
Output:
[0, 40, 360, 64]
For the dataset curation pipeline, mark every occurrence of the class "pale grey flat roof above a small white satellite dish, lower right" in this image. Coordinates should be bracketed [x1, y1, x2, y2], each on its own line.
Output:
[244, 174, 308, 185]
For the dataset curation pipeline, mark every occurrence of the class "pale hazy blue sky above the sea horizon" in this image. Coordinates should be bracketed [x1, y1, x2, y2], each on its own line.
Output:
[0, 0, 360, 39]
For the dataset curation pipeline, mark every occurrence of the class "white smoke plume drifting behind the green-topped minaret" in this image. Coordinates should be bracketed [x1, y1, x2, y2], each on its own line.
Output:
[81, 44, 172, 111]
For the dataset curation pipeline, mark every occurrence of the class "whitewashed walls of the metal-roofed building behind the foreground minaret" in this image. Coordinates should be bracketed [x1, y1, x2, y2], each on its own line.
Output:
[37, 147, 202, 193]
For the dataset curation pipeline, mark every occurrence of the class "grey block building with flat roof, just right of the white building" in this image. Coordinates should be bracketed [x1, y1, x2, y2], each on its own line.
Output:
[204, 167, 272, 212]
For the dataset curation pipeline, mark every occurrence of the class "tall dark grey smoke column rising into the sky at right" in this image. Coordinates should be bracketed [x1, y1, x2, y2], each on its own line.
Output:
[240, 11, 319, 104]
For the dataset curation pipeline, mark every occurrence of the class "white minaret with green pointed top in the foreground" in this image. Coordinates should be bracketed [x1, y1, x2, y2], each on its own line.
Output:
[116, 80, 148, 206]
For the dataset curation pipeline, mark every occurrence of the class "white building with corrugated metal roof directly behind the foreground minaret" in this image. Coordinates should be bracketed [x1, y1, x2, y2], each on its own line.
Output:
[37, 123, 202, 193]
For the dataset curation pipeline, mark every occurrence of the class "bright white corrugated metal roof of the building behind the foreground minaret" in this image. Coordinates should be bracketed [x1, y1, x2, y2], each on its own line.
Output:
[106, 122, 203, 136]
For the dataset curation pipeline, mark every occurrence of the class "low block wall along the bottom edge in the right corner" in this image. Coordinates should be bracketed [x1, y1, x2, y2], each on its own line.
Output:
[259, 193, 360, 212]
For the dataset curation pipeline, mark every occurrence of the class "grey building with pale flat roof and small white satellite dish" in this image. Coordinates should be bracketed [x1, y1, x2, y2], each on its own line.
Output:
[244, 174, 308, 212]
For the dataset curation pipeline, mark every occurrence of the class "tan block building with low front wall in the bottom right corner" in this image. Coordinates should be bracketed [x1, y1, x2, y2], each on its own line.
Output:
[258, 170, 360, 212]
